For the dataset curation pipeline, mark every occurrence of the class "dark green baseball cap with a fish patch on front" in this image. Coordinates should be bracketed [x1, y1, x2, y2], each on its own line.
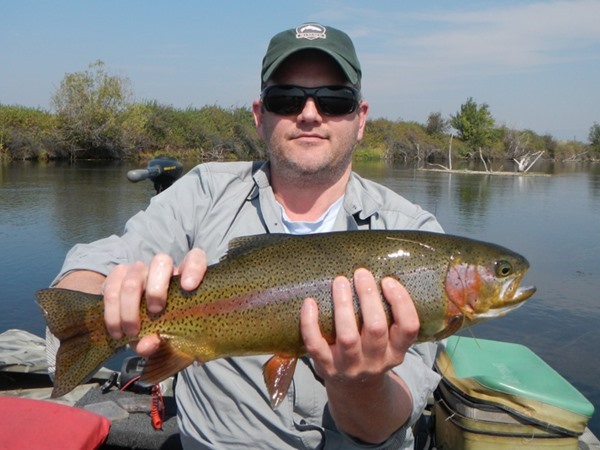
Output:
[261, 23, 362, 86]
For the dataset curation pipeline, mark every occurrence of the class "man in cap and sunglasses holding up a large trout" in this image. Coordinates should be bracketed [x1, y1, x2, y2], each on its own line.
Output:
[51, 24, 441, 449]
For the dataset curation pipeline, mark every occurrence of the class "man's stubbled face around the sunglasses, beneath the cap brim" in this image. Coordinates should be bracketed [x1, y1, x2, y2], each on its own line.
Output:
[253, 51, 368, 183]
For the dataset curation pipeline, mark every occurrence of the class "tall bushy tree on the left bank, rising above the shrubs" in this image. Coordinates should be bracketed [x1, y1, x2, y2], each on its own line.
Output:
[52, 61, 131, 158]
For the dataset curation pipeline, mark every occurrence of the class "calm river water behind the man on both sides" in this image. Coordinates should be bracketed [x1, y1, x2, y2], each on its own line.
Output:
[0, 162, 600, 435]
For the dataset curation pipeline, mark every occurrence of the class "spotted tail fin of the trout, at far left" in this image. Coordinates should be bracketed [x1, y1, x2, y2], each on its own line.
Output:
[36, 288, 127, 398]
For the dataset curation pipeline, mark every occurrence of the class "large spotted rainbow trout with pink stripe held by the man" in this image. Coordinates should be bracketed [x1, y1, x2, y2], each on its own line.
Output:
[37, 231, 535, 406]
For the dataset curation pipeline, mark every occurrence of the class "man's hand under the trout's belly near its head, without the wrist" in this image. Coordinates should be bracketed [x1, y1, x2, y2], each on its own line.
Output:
[301, 269, 419, 382]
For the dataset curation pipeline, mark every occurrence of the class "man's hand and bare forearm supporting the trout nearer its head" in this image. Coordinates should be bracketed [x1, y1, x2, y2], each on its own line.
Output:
[300, 269, 420, 443]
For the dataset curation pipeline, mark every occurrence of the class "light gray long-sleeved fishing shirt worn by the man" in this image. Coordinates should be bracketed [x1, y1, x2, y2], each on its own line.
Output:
[56, 162, 442, 450]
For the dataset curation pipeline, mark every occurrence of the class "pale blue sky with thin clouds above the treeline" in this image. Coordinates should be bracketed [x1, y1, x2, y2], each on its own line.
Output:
[0, 0, 600, 142]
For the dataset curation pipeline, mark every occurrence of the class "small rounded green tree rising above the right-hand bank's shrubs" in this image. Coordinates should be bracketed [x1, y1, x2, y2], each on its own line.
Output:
[450, 97, 496, 151]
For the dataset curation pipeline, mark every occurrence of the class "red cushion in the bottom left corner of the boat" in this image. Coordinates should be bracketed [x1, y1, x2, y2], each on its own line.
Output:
[0, 397, 110, 450]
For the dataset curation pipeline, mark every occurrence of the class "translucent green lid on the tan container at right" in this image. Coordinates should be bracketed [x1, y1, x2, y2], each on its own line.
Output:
[438, 336, 594, 418]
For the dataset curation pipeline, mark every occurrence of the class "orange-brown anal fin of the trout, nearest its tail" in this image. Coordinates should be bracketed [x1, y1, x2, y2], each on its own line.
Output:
[140, 339, 195, 386]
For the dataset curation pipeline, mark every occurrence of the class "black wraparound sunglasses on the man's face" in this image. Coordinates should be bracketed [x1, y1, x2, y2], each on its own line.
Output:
[260, 85, 360, 116]
